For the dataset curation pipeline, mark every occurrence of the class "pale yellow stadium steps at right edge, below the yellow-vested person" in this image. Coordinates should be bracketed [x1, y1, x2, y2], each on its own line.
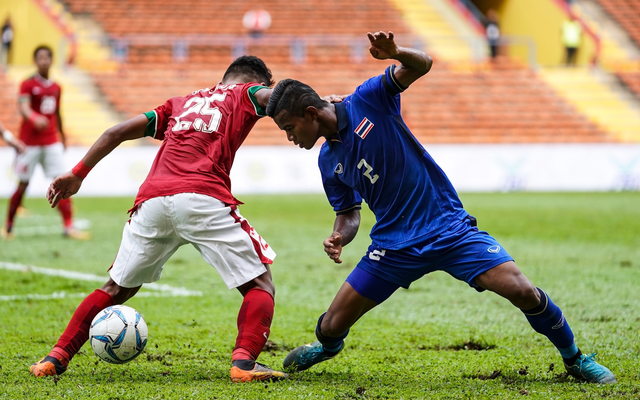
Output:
[538, 68, 640, 142]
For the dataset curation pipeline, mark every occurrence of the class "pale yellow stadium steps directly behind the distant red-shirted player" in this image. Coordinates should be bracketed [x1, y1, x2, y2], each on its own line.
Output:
[7, 67, 121, 146]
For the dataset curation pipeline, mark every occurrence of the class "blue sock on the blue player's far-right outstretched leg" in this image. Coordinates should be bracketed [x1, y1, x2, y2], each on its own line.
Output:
[522, 288, 579, 359]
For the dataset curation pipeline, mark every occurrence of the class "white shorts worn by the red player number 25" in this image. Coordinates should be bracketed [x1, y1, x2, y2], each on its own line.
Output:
[109, 193, 276, 289]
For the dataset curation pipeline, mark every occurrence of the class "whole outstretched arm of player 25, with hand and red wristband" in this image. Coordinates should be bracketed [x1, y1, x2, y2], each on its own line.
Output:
[47, 114, 148, 207]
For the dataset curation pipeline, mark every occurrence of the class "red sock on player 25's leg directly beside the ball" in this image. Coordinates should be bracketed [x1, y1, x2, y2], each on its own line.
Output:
[49, 289, 114, 365]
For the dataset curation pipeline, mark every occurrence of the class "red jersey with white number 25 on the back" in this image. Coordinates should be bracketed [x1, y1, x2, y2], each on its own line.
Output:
[134, 83, 268, 209]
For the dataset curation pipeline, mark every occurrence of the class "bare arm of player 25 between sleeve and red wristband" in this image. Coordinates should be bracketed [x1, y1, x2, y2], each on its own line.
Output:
[82, 114, 148, 168]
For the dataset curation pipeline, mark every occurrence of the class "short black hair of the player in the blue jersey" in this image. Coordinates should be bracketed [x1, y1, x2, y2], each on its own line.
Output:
[266, 79, 329, 118]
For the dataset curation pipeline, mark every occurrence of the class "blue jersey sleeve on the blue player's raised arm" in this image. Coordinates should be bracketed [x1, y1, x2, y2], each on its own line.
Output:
[354, 65, 406, 115]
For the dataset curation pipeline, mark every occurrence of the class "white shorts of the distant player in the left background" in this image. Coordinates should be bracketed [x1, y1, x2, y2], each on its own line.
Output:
[15, 143, 66, 182]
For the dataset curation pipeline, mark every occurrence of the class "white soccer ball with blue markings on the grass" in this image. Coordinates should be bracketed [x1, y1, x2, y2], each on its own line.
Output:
[89, 305, 147, 364]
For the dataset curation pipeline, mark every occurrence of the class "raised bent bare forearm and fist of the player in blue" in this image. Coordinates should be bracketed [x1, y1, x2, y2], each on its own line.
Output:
[367, 31, 433, 87]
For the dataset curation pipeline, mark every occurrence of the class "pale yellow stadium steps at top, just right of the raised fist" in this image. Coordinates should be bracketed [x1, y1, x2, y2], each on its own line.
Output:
[389, 0, 484, 62]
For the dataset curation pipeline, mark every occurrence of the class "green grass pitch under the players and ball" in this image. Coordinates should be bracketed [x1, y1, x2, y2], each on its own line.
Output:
[0, 192, 640, 399]
